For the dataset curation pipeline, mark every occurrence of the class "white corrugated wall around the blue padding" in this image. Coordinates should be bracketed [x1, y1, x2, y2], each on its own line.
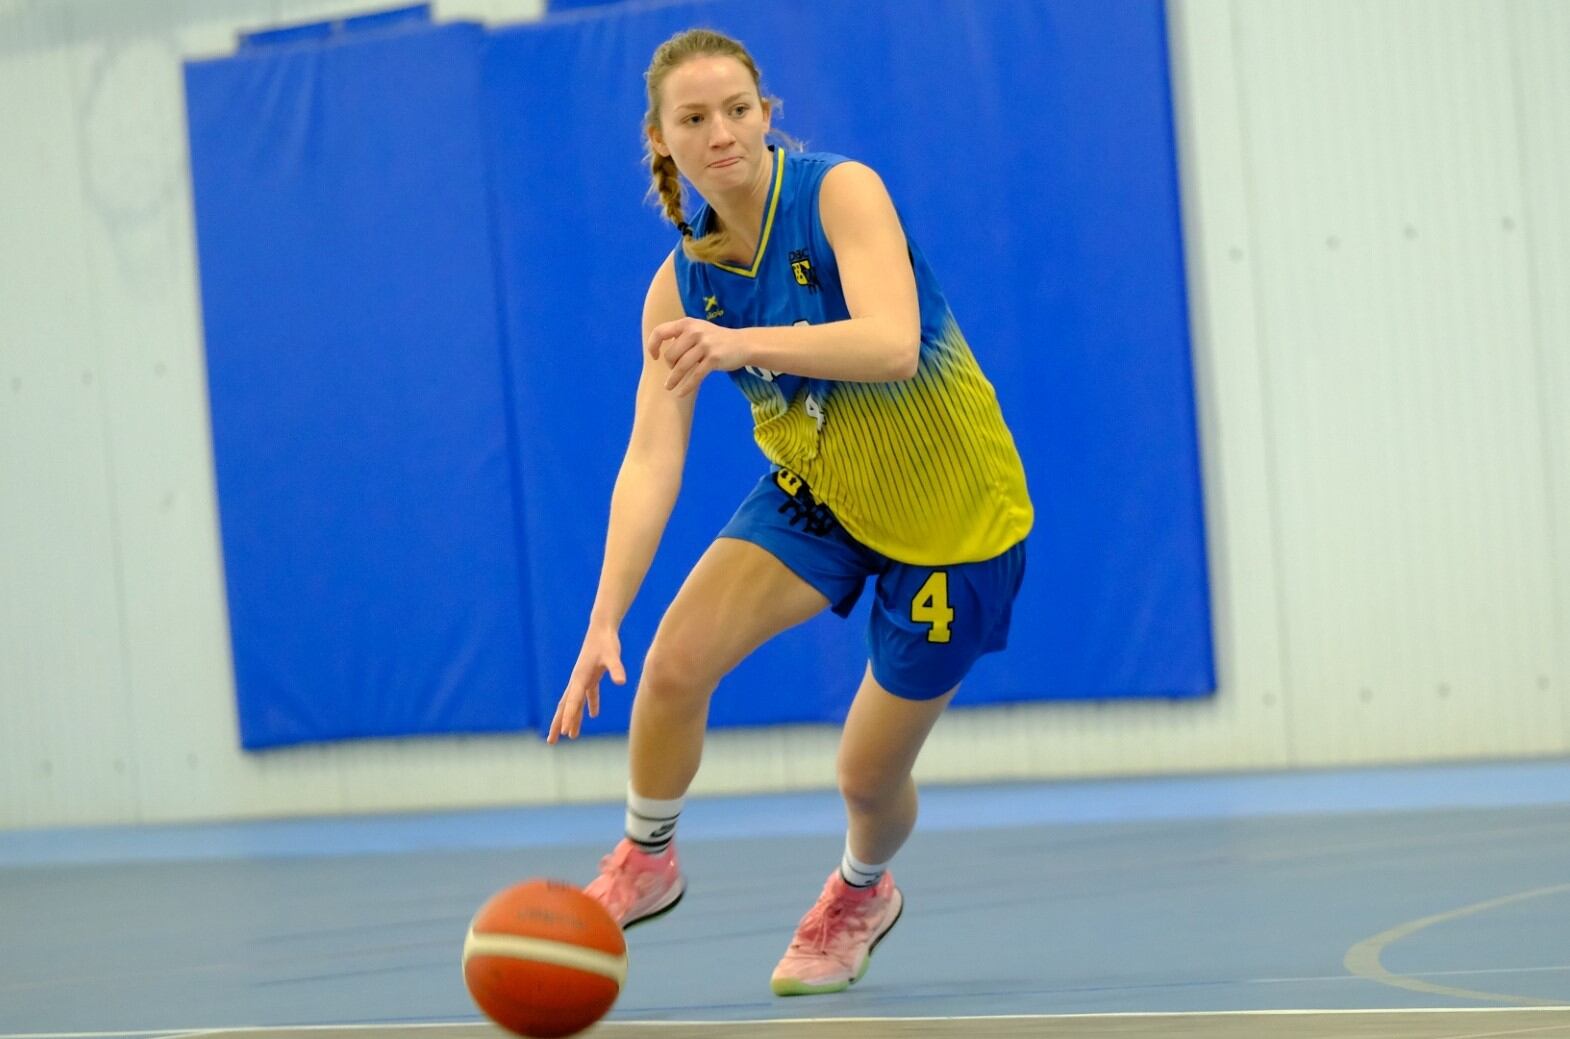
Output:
[0, 0, 1570, 827]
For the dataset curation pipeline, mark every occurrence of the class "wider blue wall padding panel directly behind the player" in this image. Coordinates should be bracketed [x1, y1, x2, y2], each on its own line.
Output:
[485, 0, 1215, 731]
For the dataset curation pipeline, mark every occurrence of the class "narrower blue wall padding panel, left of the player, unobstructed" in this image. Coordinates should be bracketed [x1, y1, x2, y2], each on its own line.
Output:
[187, 25, 540, 747]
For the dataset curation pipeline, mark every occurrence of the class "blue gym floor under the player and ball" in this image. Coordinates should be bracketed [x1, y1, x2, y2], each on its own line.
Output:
[0, 761, 1570, 1039]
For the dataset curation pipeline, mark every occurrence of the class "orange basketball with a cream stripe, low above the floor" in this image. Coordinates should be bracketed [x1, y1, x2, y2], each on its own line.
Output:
[463, 880, 626, 1039]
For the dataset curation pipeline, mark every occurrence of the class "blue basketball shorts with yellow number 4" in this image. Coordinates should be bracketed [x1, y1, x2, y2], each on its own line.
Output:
[719, 469, 1025, 700]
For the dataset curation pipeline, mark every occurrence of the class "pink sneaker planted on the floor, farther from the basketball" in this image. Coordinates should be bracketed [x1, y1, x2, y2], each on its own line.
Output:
[769, 869, 904, 995]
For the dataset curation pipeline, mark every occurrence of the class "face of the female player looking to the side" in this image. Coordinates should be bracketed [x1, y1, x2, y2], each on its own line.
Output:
[652, 55, 769, 195]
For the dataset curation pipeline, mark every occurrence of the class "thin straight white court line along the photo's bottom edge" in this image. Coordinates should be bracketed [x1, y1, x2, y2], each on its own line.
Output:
[9, 1003, 1570, 1039]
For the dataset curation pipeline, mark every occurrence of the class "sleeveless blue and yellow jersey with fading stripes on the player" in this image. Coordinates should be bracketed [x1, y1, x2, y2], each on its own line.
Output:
[675, 148, 1033, 567]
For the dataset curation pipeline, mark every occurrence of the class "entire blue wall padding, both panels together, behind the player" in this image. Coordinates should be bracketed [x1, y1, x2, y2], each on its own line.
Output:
[187, 0, 1214, 746]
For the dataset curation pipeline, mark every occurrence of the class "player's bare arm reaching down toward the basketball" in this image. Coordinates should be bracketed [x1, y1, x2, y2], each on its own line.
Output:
[545, 257, 694, 744]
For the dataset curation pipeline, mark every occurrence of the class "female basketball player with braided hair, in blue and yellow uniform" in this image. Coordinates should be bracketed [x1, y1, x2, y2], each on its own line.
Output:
[548, 30, 1031, 995]
